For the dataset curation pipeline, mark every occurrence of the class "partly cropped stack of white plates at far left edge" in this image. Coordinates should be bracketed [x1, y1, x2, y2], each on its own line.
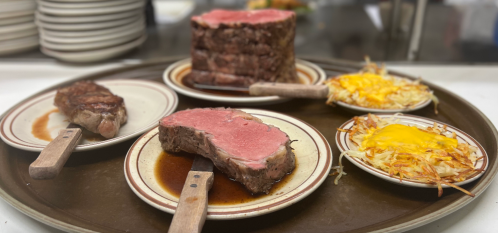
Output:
[0, 0, 39, 55]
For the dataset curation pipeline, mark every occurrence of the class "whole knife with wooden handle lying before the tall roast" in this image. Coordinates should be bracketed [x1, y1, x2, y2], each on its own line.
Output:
[194, 82, 329, 99]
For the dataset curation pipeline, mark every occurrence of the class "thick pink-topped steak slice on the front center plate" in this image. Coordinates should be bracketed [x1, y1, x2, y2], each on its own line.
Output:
[159, 108, 295, 193]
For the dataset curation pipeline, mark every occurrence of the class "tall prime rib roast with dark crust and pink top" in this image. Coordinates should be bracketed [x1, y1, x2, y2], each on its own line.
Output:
[186, 9, 299, 87]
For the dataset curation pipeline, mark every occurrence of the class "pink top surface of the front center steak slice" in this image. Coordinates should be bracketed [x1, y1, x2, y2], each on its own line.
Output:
[161, 109, 288, 166]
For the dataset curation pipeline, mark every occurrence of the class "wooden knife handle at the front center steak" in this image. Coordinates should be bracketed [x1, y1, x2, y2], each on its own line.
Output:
[168, 171, 214, 233]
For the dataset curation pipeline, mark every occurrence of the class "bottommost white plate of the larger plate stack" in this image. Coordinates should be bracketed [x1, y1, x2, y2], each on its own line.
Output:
[41, 35, 147, 63]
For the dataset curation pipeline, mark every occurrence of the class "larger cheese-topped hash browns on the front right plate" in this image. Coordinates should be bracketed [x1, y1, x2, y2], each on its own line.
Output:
[335, 114, 482, 197]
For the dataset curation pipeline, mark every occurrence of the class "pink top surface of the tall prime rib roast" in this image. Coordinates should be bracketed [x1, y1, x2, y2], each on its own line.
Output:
[192, 9, 294, 27]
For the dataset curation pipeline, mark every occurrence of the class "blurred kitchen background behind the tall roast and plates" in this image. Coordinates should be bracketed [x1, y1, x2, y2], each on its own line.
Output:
[0, 0, 498, 63]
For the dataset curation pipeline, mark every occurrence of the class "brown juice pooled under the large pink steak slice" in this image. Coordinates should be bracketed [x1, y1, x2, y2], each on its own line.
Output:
[154, 151, 297, 205]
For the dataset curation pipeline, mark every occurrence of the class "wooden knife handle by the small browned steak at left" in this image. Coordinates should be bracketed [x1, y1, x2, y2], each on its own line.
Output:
[29, 128, 81, 180]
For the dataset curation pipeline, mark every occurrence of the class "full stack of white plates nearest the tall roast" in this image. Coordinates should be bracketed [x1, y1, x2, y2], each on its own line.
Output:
[36, 0, 146, 62]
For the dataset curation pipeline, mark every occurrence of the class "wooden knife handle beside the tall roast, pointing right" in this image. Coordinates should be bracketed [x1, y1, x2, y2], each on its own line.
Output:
[249, 82, 329, 99]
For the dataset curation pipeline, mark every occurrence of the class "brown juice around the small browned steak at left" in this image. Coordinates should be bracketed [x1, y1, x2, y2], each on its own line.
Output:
[31, 109, 107, 142]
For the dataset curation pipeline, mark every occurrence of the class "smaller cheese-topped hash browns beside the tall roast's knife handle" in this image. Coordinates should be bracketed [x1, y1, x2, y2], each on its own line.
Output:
[324, 57, 438, 113]
